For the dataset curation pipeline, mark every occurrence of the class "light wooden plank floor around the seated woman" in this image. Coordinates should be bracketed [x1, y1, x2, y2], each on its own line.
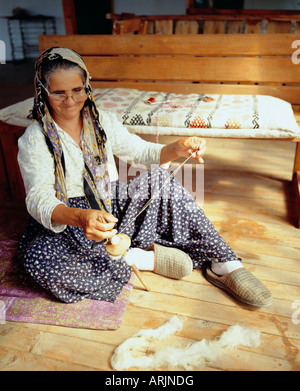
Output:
[0, 140, 300, 371]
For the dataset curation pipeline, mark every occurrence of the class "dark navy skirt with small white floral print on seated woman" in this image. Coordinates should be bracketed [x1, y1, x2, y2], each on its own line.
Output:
[19, 168, 238, 302]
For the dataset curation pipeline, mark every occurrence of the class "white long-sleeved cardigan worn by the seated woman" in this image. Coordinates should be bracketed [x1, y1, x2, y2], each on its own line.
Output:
[18, 111, 163, 232]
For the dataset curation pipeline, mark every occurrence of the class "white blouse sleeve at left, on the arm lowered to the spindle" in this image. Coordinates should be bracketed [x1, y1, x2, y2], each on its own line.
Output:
[18, 122, 66, 232]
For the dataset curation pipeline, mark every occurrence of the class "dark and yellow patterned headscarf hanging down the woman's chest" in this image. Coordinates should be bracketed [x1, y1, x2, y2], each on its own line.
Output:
[32, 47, 111, 212]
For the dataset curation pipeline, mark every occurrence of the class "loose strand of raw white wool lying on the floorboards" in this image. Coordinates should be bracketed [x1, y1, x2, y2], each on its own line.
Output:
[111, 316, 260, 371]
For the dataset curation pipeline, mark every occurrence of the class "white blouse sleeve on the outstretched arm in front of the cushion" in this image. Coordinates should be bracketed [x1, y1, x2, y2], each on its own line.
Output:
[99, 110, 164, 168]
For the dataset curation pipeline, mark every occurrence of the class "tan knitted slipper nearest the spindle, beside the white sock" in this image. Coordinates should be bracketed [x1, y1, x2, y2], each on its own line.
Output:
[151, 243, 193, 280]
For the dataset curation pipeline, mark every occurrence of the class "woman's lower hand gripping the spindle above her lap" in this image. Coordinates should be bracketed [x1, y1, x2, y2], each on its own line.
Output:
[78, 209, 118, 241]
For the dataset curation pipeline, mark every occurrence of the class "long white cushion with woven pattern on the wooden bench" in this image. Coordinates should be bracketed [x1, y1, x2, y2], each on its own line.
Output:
[0, 88, 300, 138]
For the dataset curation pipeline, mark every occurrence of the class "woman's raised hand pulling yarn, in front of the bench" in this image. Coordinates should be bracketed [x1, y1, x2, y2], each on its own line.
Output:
[175, 137, 206, 164]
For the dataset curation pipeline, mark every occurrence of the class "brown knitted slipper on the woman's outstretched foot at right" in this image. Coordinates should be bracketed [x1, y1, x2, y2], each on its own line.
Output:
[205, 267, 273, 307]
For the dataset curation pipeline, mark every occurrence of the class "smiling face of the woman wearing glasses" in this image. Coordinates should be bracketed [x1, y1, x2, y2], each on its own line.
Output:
[48, 69, 85, 120]
